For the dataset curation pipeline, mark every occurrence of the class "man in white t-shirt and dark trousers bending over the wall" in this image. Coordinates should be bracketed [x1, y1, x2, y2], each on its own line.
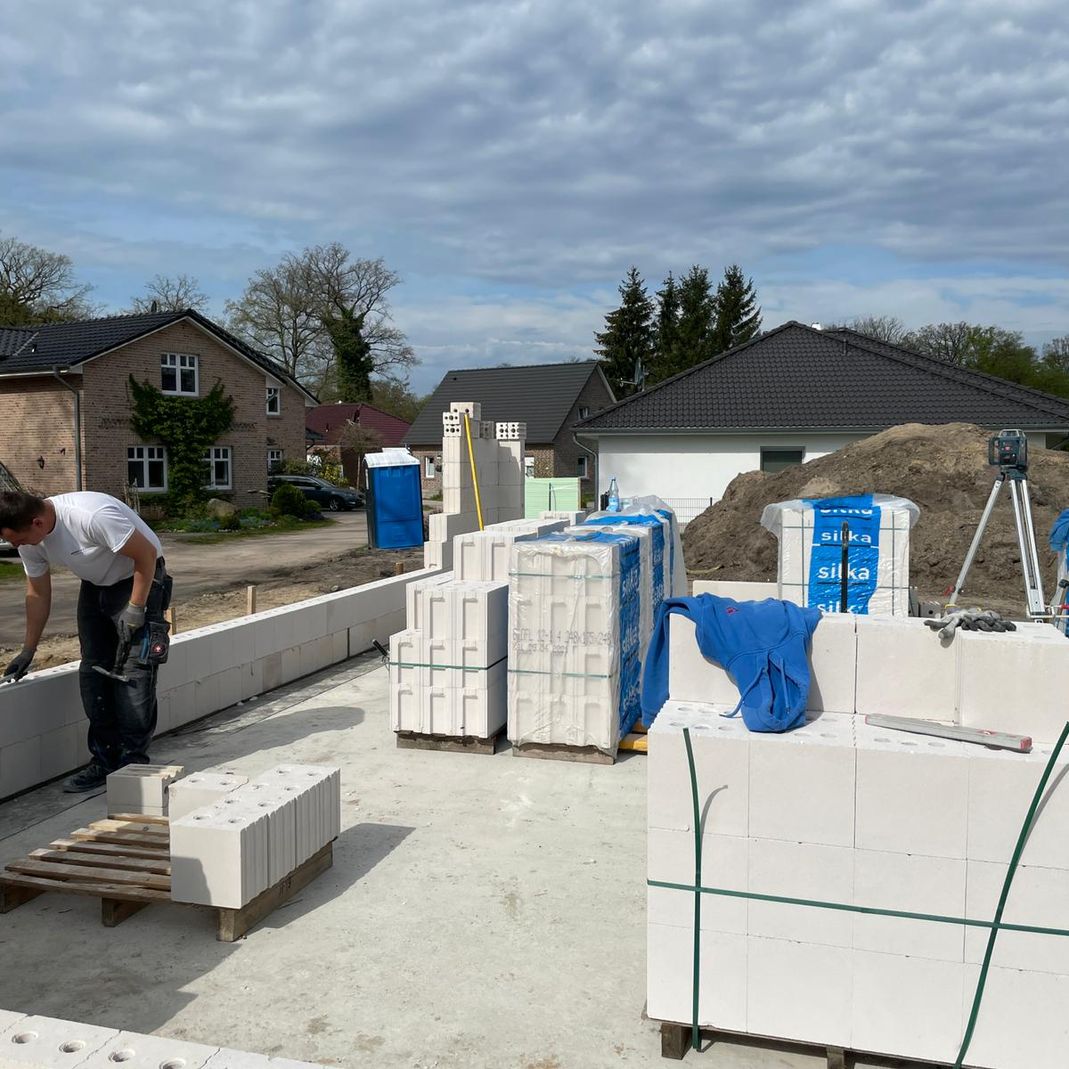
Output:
[0, 491, 170, 793]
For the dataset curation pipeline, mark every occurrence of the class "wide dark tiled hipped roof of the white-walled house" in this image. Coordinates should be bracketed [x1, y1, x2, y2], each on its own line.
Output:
[576, 321, 1069, 434]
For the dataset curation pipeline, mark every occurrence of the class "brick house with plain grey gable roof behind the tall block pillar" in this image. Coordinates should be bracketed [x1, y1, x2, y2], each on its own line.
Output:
[405, 360, 616, 498]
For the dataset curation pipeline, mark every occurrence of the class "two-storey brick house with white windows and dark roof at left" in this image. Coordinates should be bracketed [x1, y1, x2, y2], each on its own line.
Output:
[0, 309, 315, 508]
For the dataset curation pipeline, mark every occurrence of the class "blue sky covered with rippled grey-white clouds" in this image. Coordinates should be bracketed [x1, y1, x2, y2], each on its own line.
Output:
[0, 0, 1069, 390]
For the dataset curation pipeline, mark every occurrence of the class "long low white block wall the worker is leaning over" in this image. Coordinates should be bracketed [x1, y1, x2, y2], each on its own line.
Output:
[0, 568, 438, 799]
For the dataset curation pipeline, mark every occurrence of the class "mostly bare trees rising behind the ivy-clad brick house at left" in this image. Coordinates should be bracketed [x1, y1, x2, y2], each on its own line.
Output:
[0, 235, 423, 421]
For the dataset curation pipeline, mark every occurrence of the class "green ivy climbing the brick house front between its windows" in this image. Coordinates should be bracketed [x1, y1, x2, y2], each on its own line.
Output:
[129, 375, 234, 502]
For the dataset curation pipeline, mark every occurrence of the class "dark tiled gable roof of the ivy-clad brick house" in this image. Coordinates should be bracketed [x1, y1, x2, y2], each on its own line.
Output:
[0, 308, 315, 402]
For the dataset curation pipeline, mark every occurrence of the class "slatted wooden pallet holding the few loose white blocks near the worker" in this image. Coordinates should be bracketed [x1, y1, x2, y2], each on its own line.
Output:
[0, 815, 334, 943]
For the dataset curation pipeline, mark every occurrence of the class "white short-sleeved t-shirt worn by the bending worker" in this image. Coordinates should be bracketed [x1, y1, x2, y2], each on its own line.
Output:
[18, 492, 162, 587]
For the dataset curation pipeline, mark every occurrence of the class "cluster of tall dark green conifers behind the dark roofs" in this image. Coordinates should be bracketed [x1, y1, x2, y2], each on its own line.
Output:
[594, 264, 761, 398]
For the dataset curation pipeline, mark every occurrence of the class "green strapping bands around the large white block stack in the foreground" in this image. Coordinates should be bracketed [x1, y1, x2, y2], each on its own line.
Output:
[671, 723, 1069, 1069]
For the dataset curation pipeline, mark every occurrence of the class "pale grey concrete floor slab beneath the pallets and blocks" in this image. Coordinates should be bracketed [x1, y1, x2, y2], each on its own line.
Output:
[0, 659, 915, 1069]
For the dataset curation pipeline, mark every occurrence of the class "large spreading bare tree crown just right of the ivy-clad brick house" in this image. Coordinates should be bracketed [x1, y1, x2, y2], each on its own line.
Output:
[227, 242, 416, 383]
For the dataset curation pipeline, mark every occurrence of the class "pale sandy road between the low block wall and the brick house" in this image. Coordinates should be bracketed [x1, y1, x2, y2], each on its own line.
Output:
[0, 512, 368, 647]
